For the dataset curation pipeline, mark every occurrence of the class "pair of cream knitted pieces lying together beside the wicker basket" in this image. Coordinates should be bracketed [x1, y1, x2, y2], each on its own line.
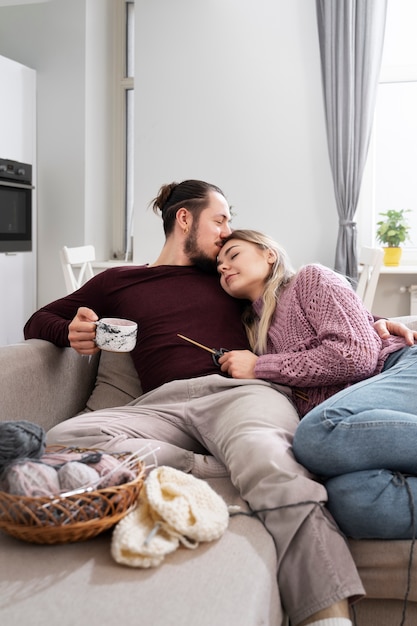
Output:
[111, 466, 229, 567]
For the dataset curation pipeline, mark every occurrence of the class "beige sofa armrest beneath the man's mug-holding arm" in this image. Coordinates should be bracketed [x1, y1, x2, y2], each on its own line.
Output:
[0, 339, 99, 430]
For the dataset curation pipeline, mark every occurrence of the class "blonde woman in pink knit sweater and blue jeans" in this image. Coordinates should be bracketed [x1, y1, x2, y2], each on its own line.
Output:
[218, 230, 417, 538]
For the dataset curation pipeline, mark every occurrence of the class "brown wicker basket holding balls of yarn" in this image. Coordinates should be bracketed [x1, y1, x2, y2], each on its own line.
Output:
[0, 449, 145, 544]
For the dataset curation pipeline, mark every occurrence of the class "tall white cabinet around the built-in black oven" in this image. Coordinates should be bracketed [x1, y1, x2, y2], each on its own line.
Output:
[0, 56, 36, 346]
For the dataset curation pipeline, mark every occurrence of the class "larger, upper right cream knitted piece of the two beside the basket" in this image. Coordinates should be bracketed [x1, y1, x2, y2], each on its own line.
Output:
[145, 466, 229, 543]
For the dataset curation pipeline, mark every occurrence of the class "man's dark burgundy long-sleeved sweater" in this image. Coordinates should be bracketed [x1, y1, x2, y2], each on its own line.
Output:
[25, 265, 248, 391]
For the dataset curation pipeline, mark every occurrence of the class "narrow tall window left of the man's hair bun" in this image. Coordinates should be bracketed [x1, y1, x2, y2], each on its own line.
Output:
[113, 0, 135, 260]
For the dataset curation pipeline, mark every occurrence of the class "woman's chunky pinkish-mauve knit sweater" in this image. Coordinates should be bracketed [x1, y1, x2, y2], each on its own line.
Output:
[253, 265, 405, 416]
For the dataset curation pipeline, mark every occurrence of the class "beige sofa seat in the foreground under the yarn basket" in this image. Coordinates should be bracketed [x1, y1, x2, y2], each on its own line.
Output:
[0, 479, 282, 626]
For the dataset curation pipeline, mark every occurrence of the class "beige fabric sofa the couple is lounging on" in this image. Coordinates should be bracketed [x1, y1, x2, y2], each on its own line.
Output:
[0, 318, 417, 626]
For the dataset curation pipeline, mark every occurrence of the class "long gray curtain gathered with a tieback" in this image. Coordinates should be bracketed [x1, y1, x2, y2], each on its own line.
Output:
[316, 0, 388, 284]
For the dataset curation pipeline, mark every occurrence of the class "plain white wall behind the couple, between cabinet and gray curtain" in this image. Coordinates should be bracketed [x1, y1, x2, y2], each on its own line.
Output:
[0, 0, 337, 306]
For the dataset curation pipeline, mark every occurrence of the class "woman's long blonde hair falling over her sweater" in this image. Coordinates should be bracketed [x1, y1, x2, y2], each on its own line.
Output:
[223, 229, 295, 354]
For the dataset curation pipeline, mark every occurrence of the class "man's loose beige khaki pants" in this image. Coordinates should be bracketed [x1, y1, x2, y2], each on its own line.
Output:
[47, 374, 364, 625]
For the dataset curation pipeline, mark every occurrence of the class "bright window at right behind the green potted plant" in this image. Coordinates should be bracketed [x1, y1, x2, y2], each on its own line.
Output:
[357, 0, 417, 254]
